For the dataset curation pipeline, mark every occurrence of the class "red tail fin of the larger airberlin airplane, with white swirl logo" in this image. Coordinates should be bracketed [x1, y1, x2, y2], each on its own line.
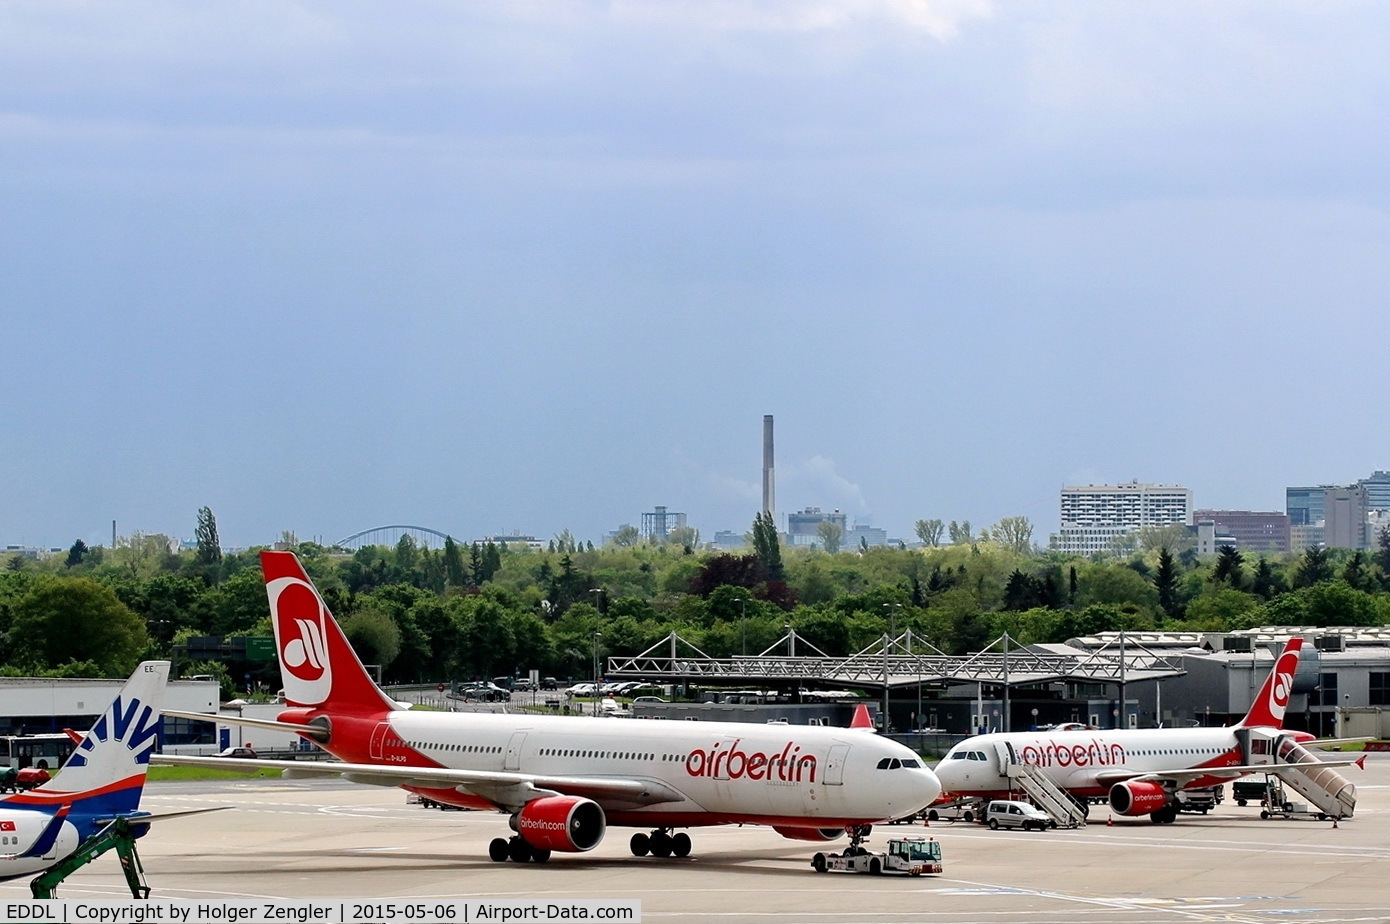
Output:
[261, 552, 399, 716]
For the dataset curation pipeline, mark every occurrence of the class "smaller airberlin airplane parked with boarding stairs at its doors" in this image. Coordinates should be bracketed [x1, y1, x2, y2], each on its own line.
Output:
[937, 638, 1364, 824]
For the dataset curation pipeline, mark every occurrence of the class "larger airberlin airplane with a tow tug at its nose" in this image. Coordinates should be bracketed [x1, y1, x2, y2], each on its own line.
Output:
[157, 552, 941, 861]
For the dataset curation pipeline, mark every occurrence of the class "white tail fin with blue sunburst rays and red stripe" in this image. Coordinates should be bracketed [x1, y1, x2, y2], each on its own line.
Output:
[4, 661, 170, 816]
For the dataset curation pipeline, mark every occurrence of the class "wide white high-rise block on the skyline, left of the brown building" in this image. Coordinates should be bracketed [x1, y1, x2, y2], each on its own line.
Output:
[1048, 481, 1193, 554]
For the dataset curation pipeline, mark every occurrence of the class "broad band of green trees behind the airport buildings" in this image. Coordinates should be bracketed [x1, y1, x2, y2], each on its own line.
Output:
[0, 509, 1390, 694]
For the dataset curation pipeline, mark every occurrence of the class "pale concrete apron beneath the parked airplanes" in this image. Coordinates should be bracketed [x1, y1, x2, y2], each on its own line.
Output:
[0, 753, 1390, 924]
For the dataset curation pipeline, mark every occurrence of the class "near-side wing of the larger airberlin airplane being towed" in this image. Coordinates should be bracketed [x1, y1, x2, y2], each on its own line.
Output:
[150, 754, 685, 810]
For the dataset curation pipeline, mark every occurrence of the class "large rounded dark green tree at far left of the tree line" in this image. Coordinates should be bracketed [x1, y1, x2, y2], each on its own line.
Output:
[10, 575, 149, 677]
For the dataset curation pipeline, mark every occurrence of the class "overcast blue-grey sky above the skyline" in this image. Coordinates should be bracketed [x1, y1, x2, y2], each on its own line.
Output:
[0, 0, 1390, 546]
